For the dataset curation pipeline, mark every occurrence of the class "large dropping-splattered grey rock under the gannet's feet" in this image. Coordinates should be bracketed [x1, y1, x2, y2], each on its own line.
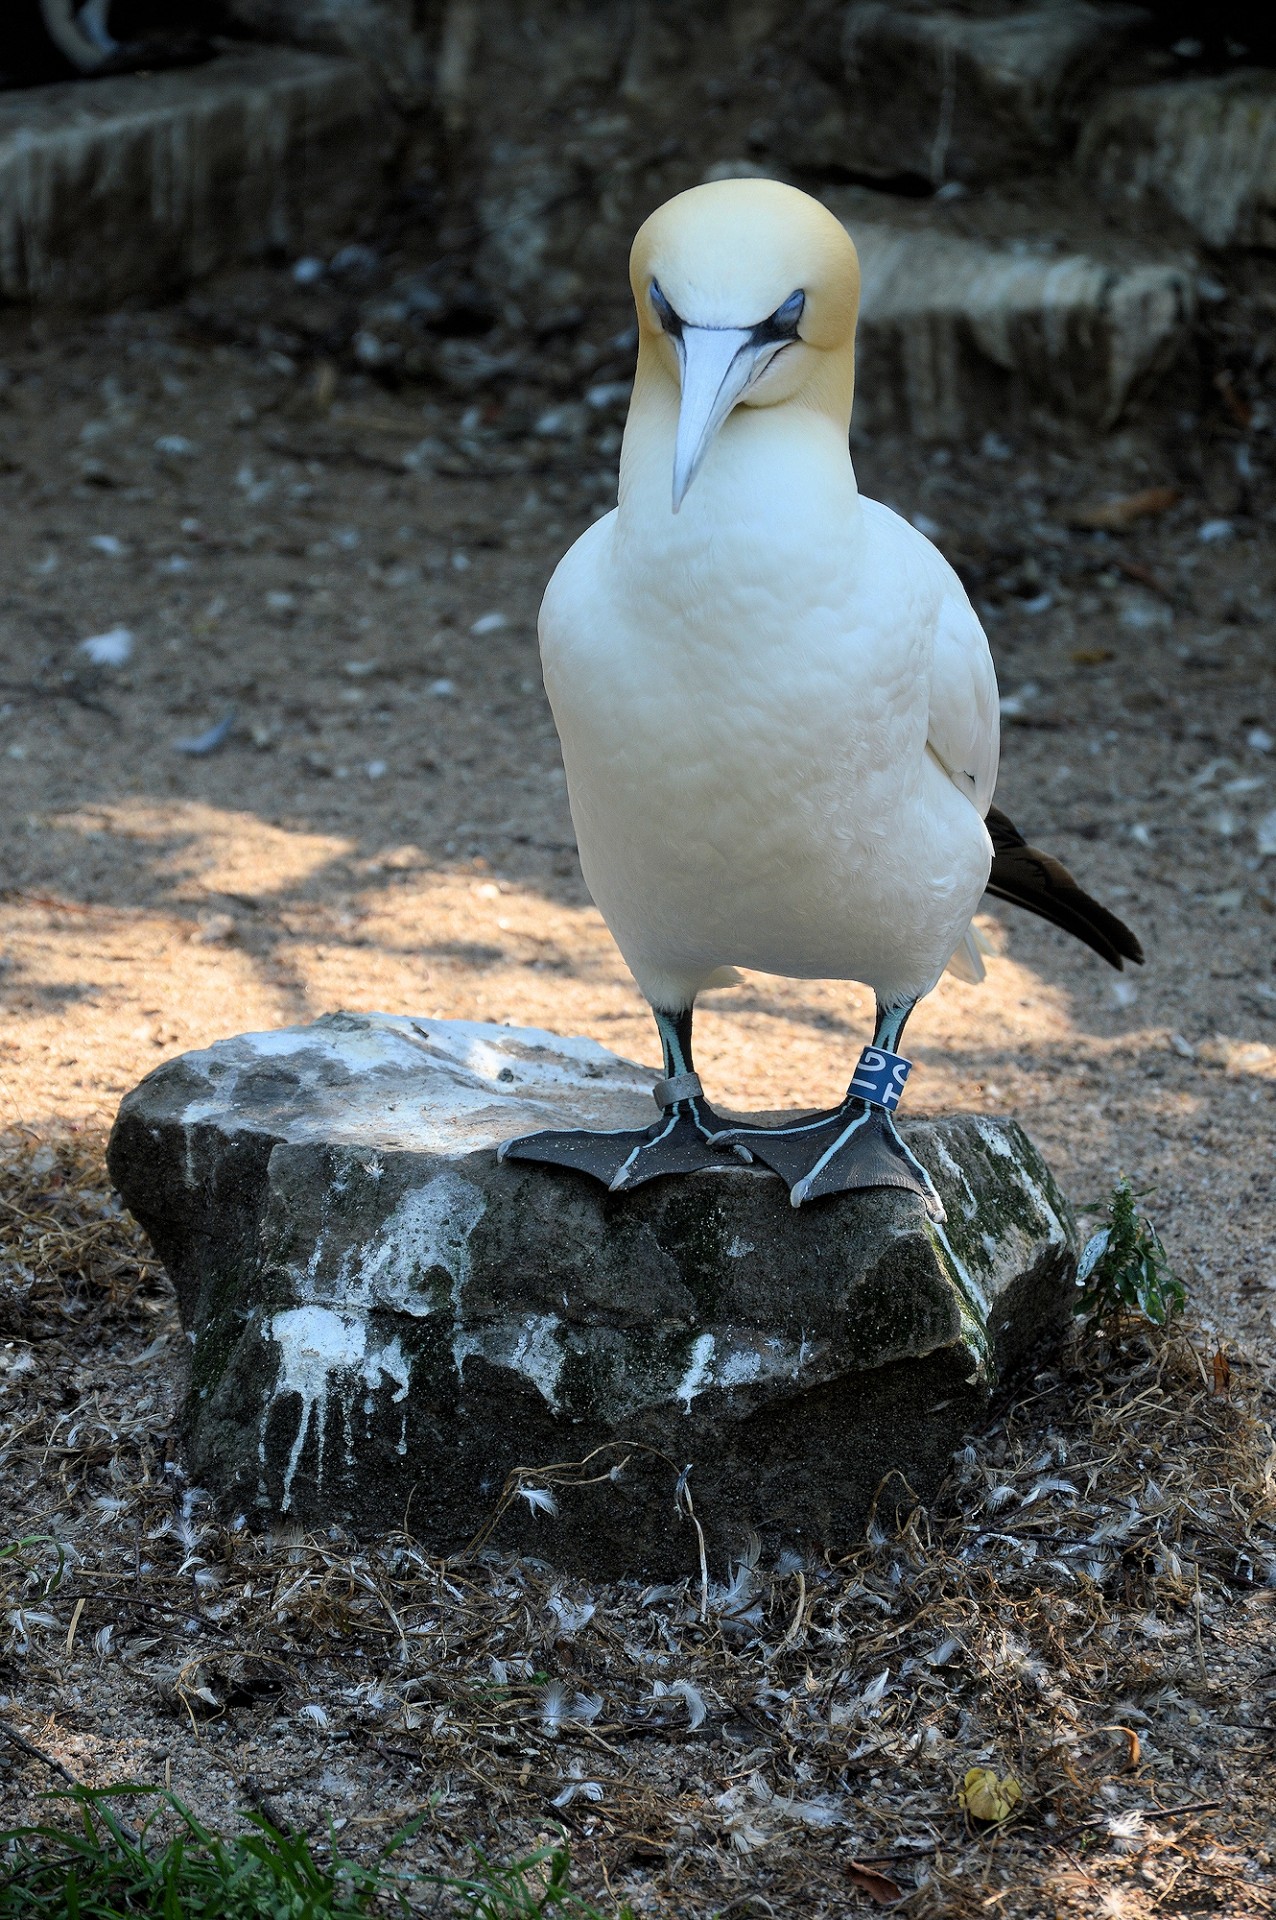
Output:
[109, 1014, 1076, 1574]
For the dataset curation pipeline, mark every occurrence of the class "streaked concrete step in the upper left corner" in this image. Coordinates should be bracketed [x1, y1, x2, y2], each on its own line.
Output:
[0, 46, 395, 307]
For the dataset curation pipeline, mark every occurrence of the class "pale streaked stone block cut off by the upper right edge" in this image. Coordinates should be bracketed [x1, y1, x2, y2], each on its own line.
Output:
[1076, 71, 1276, 248]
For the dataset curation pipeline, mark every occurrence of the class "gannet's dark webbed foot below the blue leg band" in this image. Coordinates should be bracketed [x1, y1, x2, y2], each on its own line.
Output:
[716, 1096, 944, 1221]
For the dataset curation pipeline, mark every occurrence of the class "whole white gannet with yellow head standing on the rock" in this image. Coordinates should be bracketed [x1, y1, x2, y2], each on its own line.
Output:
[503, 180, 1142, 1213]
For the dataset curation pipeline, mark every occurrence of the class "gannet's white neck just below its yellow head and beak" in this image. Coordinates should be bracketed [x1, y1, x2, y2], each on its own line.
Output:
[618, 353, 858, 559]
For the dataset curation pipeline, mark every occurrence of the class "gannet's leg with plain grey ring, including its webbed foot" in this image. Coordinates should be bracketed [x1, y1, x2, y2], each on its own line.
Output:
[489, 1006, 750, 1192]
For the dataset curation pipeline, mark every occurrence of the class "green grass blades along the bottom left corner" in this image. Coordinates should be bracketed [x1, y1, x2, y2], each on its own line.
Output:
[0, 1786, 631, 1920]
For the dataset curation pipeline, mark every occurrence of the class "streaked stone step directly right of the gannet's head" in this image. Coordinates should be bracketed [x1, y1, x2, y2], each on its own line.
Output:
[825, 188, 1195, 440]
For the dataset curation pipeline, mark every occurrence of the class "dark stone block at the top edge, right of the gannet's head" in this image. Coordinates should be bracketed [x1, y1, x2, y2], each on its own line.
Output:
[785, 0, 1147, 186]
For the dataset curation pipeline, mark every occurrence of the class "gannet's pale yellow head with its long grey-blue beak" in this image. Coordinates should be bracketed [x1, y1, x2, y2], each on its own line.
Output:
[629, 180, 860, 513]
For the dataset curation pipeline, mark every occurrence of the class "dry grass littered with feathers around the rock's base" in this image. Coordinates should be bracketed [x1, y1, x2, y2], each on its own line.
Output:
[0, 1133, 1276, 1916]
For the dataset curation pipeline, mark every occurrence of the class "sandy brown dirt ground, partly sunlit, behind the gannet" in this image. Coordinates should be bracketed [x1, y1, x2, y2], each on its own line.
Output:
[0, 228, 1276, 1916]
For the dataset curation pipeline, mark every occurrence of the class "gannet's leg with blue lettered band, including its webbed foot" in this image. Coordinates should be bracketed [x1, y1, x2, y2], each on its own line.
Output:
[716, 1000, 944, 1219]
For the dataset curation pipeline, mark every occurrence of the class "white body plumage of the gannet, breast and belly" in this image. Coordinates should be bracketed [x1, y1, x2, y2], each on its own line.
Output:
[541, 180, 998, 1008]
